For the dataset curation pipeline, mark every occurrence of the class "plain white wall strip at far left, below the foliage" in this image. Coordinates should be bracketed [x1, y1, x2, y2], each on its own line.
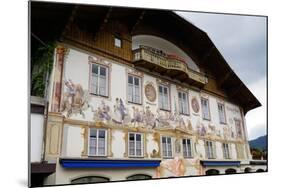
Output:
[30, 113, 44, 162]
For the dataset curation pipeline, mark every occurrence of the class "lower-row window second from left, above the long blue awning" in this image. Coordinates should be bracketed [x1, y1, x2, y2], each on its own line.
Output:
[129, 133, 143, 157]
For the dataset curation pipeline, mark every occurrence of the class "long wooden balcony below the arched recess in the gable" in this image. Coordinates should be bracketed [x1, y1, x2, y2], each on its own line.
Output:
[133, 46, 208, 87]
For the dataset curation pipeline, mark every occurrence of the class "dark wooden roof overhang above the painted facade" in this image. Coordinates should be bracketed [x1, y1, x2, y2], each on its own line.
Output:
[31, 2, 261, 114]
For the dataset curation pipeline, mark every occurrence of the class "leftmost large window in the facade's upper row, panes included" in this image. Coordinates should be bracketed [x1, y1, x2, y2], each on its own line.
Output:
[91, 64, 108, 96]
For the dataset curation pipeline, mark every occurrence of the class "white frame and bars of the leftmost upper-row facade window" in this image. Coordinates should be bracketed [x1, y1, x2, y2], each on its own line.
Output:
[90, 63, 109, 97]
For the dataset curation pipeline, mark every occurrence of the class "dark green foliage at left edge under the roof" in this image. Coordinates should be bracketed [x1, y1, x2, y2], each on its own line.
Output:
[31, 42, 55, 97]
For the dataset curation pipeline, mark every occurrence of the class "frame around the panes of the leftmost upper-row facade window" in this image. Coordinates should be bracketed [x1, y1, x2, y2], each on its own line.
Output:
[89, 62, 110, 98]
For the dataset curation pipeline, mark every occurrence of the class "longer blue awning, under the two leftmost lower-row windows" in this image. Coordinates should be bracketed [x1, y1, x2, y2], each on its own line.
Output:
[60, 159, 161, 168]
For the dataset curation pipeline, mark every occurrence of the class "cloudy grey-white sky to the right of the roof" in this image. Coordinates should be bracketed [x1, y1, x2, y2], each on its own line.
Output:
[176, 12, 267, 139]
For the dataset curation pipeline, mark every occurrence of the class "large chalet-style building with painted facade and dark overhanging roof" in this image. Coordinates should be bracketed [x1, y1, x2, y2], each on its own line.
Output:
[31, 2, 267, 186]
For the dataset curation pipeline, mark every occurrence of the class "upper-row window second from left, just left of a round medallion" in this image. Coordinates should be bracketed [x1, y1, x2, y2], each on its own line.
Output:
[128, 75, 141, 104]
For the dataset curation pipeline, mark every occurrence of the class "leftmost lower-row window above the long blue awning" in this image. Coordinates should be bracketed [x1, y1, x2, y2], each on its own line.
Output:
[89, 128, 107, 156]
